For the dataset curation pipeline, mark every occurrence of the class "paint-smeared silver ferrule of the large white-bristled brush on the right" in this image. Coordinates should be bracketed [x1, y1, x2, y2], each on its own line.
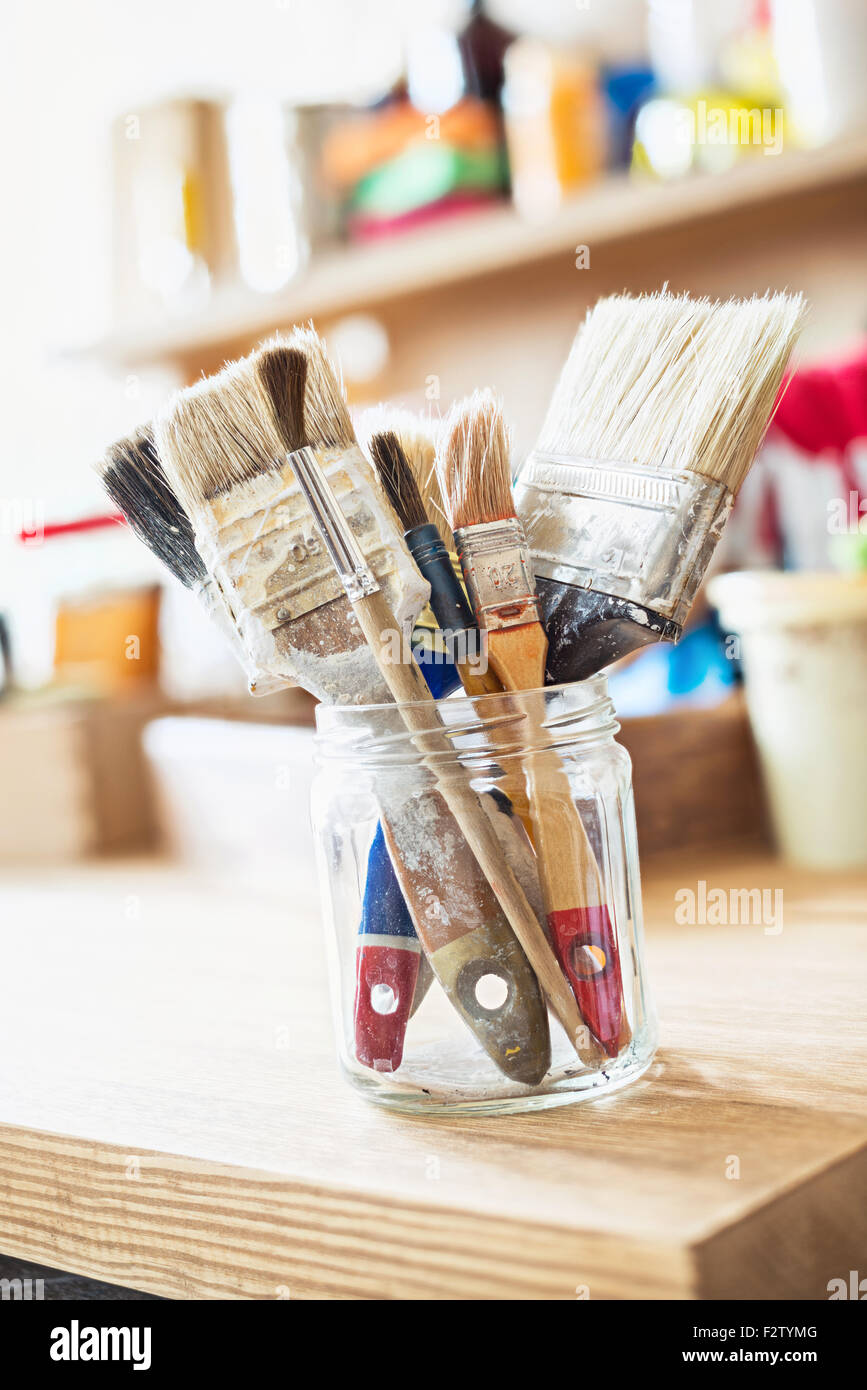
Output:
[515, 453, 732, 624]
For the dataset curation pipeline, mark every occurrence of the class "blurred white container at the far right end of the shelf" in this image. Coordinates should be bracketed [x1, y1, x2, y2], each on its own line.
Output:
[771, 0, 867, 145]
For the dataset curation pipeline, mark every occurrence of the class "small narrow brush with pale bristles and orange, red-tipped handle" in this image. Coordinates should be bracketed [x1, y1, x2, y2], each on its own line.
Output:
[439, 391, 631, 1056]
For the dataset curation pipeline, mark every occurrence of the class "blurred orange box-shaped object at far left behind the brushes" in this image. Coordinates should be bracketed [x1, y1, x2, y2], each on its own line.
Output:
[54, 584, 161, 695]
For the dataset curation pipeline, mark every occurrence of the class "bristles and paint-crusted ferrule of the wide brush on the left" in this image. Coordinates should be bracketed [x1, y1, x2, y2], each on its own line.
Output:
[154, 328, 428, 705]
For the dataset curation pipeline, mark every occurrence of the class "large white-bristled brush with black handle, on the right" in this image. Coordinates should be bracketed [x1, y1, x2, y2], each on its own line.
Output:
[515, 291, 804, 684]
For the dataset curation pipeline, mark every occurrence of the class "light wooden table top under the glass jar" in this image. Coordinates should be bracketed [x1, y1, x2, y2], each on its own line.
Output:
[0, 858, 867, 1298]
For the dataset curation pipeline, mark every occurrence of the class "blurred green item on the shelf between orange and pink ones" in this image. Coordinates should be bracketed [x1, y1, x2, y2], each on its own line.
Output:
[350, 142, 506, 217]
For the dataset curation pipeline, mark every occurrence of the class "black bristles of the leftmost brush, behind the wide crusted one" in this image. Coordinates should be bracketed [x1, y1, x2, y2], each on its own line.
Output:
[99, 425, 207, 588]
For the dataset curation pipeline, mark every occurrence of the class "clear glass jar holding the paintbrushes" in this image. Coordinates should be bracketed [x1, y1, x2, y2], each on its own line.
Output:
[313, 676, 656, 1113]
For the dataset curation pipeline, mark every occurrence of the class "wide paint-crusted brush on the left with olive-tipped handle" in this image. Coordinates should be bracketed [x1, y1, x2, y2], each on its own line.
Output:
[157, 341, 550, 1084]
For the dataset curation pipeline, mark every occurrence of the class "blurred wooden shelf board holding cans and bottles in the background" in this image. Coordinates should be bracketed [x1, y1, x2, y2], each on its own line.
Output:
[71, 135, 867, 366]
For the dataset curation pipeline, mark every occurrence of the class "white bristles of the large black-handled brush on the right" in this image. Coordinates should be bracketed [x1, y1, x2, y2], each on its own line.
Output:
[536, 291, 804, 492]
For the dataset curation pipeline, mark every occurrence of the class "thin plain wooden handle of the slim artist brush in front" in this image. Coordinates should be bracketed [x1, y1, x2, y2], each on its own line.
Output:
[353, 591, 604, 1066]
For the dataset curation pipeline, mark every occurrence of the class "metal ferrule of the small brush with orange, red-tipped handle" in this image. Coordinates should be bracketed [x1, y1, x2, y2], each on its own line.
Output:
[454, 517, 539, 631]
